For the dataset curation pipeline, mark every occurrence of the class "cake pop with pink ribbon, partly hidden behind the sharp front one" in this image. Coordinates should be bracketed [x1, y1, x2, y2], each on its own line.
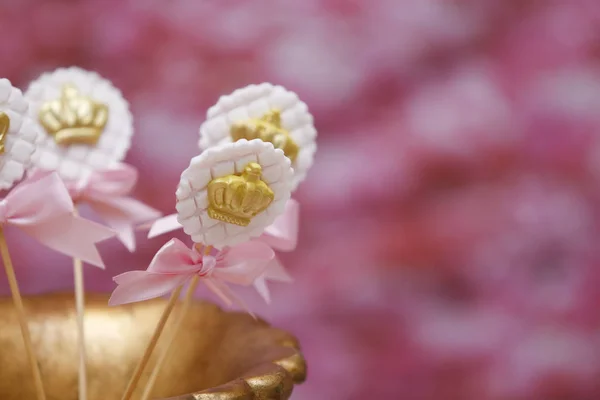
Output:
[148, 83, 317, 300]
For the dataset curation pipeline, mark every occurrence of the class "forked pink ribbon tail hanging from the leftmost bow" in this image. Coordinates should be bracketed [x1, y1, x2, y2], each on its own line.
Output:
[20, 214, 115, 269]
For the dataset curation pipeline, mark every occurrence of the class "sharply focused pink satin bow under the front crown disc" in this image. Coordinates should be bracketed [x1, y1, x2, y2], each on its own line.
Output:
[108, 239, 275, 308]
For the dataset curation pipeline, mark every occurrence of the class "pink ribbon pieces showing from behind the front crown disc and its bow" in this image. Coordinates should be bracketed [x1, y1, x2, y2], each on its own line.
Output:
[146, 199, 300, 303]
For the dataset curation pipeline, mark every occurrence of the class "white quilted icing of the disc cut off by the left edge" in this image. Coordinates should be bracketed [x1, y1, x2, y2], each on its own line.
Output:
[0, 79, 39, 189]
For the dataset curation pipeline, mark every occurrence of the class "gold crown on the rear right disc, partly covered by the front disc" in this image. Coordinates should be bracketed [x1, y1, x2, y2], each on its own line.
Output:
[229, 109, 300, 162]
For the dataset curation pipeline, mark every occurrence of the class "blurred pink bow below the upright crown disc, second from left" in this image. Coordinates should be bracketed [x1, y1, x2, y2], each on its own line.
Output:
[65, 164, 161, 251]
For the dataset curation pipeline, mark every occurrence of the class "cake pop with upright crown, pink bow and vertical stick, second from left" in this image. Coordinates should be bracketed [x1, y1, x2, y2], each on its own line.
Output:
[25, 67, 160, 400]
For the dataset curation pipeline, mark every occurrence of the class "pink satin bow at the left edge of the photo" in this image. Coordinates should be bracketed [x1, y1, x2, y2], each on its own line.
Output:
[0, 173, 115, 268]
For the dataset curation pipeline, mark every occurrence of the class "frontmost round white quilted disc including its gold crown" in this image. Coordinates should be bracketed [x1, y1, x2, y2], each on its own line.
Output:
[176, 139, 293, 249]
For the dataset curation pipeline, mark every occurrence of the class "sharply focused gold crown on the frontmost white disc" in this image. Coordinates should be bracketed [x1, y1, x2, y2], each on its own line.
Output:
[207, 162, 275, 226]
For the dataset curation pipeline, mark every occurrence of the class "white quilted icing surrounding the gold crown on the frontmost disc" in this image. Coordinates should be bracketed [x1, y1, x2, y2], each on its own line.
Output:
[176, 139, 293, 249]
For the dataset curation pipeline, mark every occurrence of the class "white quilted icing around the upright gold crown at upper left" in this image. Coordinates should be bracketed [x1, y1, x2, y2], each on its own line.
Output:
[25, 67, 133, 180]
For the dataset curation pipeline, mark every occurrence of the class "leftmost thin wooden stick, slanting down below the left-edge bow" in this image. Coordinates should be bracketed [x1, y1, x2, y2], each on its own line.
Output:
[0, 227, 46, 400]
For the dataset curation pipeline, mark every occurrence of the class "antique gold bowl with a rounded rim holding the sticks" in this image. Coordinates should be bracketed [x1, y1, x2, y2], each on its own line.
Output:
[0, 294, 306, 400]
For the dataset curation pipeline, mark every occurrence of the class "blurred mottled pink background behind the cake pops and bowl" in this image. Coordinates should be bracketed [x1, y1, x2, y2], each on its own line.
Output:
[0, 0, 600, 400]
